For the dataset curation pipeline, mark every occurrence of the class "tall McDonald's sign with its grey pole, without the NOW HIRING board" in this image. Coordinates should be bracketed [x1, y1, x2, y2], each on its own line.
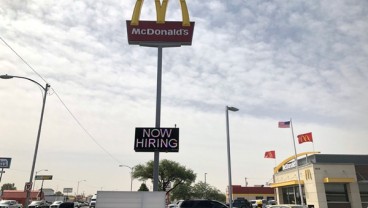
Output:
[126, 0, 194, 191]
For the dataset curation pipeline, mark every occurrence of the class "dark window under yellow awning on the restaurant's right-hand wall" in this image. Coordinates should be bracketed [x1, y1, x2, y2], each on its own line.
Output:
[325, 183, 349, 202]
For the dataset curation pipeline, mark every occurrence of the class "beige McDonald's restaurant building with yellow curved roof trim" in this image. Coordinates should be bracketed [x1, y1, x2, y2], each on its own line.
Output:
[271, 152, 368, 208]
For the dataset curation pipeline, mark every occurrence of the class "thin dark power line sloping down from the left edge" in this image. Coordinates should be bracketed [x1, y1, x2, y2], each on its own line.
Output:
[0, 36, 122, 164]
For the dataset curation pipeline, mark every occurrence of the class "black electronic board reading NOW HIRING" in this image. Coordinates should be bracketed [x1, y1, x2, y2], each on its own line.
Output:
[134, 128, 179, 152]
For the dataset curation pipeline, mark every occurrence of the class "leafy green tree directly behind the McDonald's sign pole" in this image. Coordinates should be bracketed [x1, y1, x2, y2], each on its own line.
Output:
[133, 159, 196, 192]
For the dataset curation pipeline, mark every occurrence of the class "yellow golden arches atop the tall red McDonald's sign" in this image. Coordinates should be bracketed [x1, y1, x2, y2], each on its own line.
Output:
[130, 0, 190, 26]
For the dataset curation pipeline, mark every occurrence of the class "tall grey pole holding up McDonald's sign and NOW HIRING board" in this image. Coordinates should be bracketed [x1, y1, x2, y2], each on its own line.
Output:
[153, 46, 162, 191]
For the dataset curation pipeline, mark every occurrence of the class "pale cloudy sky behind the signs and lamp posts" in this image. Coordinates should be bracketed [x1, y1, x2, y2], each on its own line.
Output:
[0, 0, 368, 194]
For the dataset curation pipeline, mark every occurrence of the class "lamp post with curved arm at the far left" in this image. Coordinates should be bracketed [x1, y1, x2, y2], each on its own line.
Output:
[0, 74, 50, 208]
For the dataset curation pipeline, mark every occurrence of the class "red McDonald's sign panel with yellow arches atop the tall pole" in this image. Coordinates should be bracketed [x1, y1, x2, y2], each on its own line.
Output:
[126, 0, 194, 46]
